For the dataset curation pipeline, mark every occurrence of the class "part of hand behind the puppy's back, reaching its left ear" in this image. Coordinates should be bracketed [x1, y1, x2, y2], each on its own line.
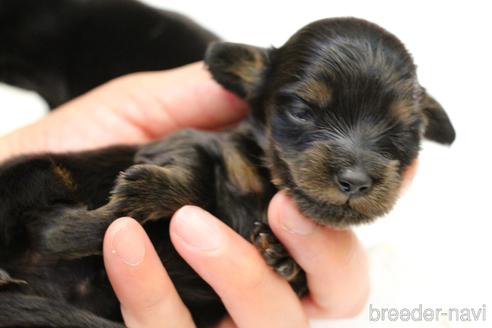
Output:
[0, 62, 247, 161]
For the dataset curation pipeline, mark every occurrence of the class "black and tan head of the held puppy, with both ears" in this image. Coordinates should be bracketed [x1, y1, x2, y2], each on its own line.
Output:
[206, 18, 455, 227]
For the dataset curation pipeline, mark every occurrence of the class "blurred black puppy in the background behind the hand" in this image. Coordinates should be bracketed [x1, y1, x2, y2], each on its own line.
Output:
[0, 0, 218, 108]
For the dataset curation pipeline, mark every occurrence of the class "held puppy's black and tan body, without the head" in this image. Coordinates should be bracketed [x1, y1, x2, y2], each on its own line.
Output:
[0, 127, 276, 326]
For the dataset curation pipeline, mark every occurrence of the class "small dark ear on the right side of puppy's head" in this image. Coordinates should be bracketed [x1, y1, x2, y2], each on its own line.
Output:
[420, 89, 456, 145]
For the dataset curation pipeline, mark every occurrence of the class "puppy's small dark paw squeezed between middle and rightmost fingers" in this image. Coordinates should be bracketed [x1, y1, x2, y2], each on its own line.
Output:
[251, 221, 307, 295]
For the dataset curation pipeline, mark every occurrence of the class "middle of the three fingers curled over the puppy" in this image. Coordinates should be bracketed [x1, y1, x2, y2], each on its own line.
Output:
[170, 206, 307, 327]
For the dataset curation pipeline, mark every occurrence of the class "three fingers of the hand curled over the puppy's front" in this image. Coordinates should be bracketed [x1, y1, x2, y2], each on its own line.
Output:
[103, 161, 417, 328]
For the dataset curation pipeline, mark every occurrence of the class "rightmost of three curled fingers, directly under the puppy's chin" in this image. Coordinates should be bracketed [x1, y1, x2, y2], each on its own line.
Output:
[268, 192, 369, 318]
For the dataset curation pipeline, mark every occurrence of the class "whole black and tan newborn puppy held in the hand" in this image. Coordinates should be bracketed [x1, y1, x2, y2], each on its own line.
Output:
[0, 3, 454, 327]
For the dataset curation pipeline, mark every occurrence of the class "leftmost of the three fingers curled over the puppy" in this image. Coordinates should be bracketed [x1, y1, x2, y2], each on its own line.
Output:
[103, 218, 194, 328]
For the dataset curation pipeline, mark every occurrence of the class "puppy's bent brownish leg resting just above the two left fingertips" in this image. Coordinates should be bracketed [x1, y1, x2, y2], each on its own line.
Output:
[37, 164, 210, 259]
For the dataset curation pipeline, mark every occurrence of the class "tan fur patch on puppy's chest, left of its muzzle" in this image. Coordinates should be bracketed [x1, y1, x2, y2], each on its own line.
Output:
[223, 145, 263, 193]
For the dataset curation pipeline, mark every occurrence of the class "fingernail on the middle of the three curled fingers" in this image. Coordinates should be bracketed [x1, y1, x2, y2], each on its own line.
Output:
[173, 206, 223, 251]
